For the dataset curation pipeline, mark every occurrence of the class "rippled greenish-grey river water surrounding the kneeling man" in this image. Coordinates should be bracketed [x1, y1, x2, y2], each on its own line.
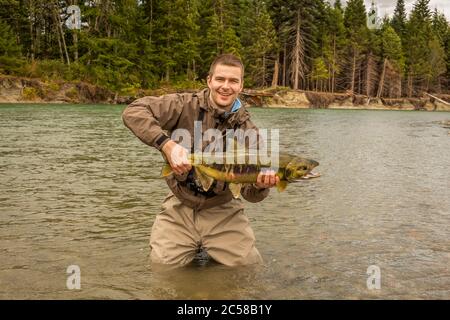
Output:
[0, 105, 450, 299]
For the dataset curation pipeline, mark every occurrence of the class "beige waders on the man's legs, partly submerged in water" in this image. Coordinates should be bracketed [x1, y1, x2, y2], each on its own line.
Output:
[150, 193, 262, 266]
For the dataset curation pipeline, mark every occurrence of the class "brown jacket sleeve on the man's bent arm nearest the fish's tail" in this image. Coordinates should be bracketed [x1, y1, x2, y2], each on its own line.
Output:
[122, 94, 184, 150]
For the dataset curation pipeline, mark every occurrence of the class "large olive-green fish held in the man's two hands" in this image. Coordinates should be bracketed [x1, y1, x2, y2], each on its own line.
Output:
[161, 153, 320, 198]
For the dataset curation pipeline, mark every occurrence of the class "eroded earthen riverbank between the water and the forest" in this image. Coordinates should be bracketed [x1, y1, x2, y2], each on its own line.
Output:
[0, 75, 450, 111]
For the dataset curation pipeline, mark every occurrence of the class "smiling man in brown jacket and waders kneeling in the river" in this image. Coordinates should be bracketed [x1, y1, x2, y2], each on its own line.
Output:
[123, 54, 279, 266]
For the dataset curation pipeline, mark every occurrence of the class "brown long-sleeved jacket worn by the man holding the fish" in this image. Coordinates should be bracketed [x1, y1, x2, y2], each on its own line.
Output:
[122, 89, 269, 210]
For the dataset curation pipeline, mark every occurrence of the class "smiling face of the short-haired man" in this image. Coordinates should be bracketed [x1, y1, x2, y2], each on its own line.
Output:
[208, 64, 243, 108]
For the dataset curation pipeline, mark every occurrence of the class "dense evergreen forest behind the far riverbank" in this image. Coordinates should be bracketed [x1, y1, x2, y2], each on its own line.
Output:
[0, 0, 450, 98]
